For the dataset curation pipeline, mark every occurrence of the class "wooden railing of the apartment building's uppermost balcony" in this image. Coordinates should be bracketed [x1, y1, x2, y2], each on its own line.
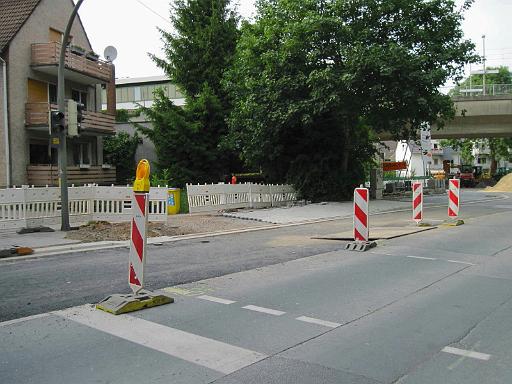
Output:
[32, 42, 112, 83]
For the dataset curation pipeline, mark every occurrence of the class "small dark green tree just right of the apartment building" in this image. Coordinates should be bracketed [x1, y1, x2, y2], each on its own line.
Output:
[103, 132, 141, 184]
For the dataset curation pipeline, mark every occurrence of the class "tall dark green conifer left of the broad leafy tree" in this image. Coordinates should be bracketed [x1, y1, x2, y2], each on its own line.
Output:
[142, 0, 239, 186]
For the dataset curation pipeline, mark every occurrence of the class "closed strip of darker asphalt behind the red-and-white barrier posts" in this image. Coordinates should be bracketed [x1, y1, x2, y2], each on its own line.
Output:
[0, 202, 498, 321]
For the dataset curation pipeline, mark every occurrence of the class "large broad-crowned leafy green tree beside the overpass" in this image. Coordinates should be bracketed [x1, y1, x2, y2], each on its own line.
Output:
[225, 0, 477, 199]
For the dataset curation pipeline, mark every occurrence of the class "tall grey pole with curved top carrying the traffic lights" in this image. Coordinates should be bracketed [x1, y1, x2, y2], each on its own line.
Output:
[57, 0, 84, 231]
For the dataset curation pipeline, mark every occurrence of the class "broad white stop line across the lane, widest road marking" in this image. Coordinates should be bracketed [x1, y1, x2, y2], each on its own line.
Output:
[53, 305, 267, 375]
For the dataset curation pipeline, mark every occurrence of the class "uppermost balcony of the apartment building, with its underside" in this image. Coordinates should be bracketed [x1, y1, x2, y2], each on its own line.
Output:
[31, 43, 112, 84]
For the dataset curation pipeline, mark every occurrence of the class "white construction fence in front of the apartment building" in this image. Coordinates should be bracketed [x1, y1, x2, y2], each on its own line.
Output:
[0, 184, 167, 230]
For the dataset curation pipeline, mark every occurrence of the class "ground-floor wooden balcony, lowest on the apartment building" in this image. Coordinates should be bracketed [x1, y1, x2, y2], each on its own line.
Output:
[27, 164, 116, 186]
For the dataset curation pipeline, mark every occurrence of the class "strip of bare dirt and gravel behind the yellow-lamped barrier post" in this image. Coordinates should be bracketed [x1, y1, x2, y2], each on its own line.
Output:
[66, 215, 270, 242]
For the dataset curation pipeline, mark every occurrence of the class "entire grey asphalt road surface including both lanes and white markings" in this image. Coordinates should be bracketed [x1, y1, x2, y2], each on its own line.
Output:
[0, 195, 512, 384]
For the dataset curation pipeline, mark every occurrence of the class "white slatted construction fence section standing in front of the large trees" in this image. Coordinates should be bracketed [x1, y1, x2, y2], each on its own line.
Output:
[187, 183, 297, 213]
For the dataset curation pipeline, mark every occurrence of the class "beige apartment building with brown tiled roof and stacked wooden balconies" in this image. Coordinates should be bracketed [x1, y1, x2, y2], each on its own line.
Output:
[0, 0, 115, 187]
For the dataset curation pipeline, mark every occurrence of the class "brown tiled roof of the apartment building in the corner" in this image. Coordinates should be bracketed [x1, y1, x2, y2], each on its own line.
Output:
[0, 0, 40, 52]
